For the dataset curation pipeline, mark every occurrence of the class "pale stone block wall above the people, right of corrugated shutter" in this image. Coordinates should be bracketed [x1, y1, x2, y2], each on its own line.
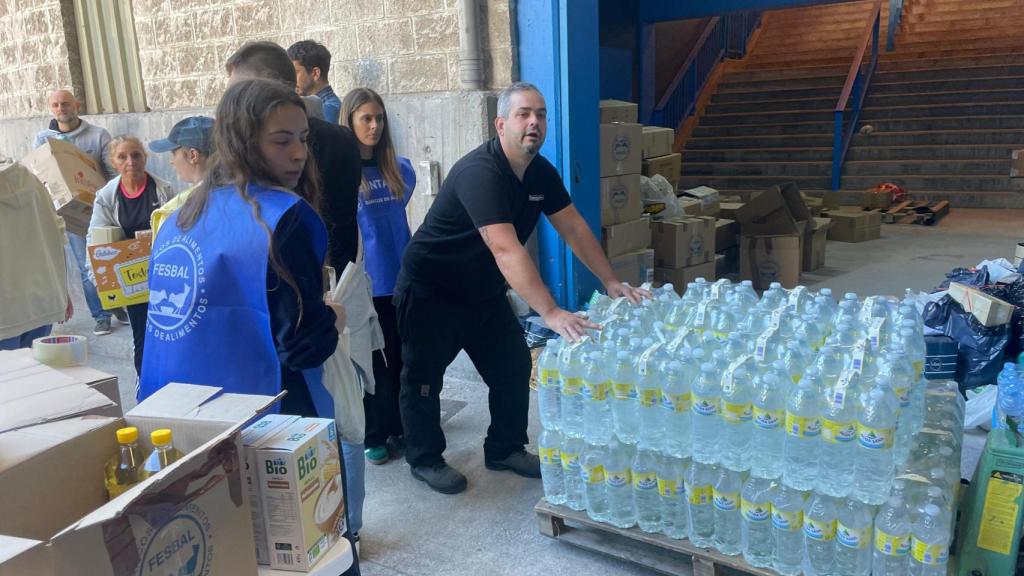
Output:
[129, 0, 515, 110]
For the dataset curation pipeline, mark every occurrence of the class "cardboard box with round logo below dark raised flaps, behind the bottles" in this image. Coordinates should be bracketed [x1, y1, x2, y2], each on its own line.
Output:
[739, 234, 803, 291]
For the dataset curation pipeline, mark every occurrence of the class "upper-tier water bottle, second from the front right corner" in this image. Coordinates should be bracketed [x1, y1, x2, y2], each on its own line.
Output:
[816, 370, 858, 498]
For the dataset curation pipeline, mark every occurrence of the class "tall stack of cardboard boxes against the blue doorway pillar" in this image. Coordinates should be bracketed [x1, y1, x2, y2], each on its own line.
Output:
[600, 100, 654, 286]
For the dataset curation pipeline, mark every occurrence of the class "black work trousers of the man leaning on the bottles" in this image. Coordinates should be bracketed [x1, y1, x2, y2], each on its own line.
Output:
[394, 292, 531, 466]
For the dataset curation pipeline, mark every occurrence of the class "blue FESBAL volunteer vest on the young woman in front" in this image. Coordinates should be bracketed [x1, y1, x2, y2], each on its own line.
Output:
[137, 184, 334, 417]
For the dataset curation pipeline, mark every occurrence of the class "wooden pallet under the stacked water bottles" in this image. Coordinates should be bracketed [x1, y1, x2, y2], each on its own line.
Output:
[535, 498, 778, 576]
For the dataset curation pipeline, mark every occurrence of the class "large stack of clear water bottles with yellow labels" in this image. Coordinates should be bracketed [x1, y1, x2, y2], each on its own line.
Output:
[538, 279, 963, 575]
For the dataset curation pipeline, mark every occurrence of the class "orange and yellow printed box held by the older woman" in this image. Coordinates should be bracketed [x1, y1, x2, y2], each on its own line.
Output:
[88, 239, 153, 310]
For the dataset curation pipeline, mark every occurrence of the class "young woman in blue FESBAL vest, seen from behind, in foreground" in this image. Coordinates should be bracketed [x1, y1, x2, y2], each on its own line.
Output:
[138, 80, 344, 418]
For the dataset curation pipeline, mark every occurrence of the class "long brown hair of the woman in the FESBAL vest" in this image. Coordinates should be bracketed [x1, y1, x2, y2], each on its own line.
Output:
[177, 79, 319, 327]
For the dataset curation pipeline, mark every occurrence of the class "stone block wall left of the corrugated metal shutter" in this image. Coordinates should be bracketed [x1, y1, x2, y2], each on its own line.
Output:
[0, 0, 81, 118]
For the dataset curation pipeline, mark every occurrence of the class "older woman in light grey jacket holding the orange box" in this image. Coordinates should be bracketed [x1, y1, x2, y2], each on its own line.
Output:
[86, 135, 174, 374]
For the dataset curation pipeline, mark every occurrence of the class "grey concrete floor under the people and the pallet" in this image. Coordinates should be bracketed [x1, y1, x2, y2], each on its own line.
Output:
[58, 209, 1024, 576]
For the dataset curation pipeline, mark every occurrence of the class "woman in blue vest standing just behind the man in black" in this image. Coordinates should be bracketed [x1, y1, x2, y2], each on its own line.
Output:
[340, 88, 416, 464]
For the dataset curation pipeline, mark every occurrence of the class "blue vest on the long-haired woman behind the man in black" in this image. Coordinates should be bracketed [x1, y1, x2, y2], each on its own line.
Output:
[356, 157, 416, 296]
